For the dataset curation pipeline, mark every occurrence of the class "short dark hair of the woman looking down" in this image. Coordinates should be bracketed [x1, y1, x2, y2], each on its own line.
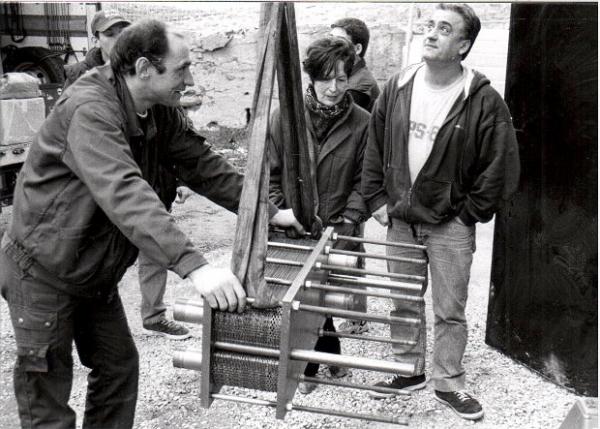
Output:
[302, 37, 356, 81]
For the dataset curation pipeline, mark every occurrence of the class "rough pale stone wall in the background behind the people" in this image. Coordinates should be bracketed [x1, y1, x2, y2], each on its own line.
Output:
[187, 25, 405, 128]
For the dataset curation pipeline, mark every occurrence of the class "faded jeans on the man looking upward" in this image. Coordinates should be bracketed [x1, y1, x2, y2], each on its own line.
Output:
[387, 218, 475, 392]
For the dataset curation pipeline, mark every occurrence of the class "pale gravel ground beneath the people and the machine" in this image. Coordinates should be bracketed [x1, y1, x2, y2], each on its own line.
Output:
[0, 197, 576, 429]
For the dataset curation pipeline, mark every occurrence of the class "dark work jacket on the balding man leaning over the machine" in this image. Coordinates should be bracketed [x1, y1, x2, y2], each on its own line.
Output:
[3, 66, 243, 296]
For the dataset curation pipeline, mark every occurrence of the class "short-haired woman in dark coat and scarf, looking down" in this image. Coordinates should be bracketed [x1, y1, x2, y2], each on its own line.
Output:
[269, 37, 369, 393]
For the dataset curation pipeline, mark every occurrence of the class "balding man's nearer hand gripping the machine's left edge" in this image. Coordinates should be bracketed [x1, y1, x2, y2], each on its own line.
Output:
[188, 264, 246, 313]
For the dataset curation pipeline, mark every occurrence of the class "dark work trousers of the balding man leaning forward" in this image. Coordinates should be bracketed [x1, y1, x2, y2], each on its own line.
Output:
[0, 250, 139, 429]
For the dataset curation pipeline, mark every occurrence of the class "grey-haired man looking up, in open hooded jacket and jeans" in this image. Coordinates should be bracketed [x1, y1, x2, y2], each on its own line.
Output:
[362, 4, 519, 419]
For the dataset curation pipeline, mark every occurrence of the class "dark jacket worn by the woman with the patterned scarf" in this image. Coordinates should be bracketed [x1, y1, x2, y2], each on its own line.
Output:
[269, 103, 369, 225]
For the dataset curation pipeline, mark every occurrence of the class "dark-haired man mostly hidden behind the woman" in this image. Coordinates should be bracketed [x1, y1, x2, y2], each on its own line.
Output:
[329, 18, 379, 112]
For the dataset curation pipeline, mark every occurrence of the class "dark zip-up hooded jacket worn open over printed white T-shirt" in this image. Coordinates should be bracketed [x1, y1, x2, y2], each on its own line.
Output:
[362, 64, 520, 225]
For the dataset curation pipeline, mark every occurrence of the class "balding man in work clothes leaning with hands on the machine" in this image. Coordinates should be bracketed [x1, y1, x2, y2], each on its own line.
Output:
[0, 20, 302, 428]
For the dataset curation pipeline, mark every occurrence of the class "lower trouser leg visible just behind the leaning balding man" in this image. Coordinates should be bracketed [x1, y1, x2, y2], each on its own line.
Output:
[138, 252, 167, 325]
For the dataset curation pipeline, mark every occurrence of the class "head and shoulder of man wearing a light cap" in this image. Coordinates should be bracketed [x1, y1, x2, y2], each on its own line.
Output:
[65, 10, 131, 88]
